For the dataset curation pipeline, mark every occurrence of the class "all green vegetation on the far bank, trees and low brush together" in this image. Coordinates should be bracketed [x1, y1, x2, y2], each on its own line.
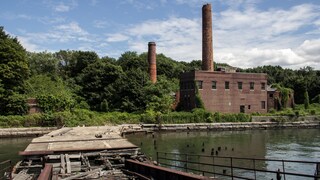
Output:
[0, 27, 320, 127]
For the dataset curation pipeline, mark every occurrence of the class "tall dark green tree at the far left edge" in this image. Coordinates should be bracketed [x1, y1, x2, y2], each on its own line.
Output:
[0, 27, 29, 115]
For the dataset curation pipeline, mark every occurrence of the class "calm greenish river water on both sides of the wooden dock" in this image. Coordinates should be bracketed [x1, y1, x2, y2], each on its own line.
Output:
[0, 129, 320, 179]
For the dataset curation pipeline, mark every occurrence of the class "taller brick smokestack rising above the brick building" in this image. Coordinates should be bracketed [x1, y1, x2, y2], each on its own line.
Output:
[202, 4, 214, 71]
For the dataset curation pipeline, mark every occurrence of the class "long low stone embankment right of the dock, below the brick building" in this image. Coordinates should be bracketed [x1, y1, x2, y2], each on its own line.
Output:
[122, 116, 320, 133]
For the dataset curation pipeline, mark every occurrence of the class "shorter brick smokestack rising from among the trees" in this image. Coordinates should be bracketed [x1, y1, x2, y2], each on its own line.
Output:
[148, 42, 157, 84]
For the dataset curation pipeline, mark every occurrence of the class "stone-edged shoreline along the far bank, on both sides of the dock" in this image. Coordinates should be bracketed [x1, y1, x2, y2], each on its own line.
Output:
[0, 120, 320, 138]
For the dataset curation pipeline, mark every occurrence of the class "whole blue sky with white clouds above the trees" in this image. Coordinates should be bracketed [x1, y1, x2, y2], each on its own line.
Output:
[0, 0, 320, 70]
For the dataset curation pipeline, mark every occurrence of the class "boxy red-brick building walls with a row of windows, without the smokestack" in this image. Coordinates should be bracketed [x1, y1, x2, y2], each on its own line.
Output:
[180, 71, 268, 113]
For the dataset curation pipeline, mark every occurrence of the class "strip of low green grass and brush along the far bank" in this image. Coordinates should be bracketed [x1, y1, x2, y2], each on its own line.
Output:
[0, 103, 320, 128]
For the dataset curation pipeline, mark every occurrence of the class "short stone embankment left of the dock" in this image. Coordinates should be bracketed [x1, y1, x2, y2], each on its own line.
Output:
[0, 127, 57, 138]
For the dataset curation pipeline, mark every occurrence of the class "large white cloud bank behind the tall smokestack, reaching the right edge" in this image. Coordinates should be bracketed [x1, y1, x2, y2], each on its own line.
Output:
[109, 0, 320, 68]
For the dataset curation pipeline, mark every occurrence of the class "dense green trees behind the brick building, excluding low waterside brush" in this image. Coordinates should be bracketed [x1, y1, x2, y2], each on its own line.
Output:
[0, 27, 320, 115]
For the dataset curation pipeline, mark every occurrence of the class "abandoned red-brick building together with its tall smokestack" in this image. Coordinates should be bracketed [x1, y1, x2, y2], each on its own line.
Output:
[179, 4, 292, 113]
